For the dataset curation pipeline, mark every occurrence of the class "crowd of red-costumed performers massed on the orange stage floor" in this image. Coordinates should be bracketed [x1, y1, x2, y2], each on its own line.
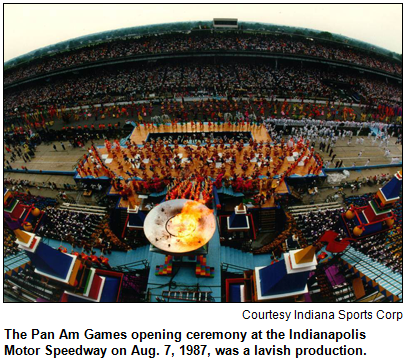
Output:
[77, 129, 323, 199]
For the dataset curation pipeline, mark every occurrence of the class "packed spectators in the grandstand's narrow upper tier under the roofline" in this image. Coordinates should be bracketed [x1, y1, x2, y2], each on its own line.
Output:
[4, 33, 402, 85]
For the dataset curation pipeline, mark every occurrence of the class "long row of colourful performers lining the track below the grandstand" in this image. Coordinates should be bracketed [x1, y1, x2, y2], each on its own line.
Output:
[5, 89, 403, 135]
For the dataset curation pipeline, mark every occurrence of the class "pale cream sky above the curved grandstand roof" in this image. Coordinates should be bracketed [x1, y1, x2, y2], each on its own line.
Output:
[4, 4, 402, 61]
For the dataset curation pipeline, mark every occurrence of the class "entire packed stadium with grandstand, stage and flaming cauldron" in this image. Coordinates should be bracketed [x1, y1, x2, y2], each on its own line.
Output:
[3, 18, 403, 303]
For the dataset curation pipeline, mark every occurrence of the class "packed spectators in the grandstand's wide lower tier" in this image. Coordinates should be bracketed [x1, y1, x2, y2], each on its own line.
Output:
[4, 63, 402, 118]
